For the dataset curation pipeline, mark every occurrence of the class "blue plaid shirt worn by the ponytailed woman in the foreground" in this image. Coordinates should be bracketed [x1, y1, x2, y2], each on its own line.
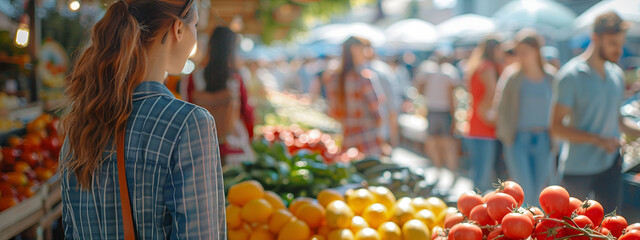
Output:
[60, 82, 226, 240]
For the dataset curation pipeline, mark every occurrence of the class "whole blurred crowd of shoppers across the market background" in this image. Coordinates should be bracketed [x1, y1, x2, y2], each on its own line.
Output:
[180, 12, 640, 210]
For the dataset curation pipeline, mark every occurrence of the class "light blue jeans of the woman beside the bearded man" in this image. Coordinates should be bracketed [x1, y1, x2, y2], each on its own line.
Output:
[505, 131, 555, 206]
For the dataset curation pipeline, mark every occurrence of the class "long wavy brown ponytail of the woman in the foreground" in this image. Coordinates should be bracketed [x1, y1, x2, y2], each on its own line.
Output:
[62, 0, 195, 189]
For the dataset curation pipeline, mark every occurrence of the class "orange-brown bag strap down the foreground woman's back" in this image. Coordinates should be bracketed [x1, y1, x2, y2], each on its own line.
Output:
[117, 125, 136, 240]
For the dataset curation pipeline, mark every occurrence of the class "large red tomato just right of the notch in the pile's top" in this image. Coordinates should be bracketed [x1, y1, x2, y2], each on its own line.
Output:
[538, 186, 572, 218]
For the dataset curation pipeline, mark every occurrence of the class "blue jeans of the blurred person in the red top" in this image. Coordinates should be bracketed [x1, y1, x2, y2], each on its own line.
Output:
[467, 138, 498, 192]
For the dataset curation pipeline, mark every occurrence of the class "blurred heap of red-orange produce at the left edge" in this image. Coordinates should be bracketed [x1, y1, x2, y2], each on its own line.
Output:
[0, 115, 63, 211]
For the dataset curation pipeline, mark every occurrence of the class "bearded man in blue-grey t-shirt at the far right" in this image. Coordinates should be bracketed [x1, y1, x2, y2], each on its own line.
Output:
[551, 12, 640, 212]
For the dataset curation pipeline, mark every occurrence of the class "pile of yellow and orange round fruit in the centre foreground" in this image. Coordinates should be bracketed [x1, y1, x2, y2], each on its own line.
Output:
[226, 180, 456, 240]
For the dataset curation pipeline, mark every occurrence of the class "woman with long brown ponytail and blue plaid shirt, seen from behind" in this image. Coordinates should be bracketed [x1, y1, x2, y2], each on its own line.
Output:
[60, 0, 226, 239]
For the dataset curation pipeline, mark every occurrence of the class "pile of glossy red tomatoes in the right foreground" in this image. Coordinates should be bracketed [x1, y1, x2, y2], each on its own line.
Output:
[440, 181, 640, 240]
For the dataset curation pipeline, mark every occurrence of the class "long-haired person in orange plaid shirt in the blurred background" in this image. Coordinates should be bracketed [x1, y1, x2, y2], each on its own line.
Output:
[328, 37, 384, 155]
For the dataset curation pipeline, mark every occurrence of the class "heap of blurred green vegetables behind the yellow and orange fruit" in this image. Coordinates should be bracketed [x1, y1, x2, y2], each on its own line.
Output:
[223, 136, 363, 201]
